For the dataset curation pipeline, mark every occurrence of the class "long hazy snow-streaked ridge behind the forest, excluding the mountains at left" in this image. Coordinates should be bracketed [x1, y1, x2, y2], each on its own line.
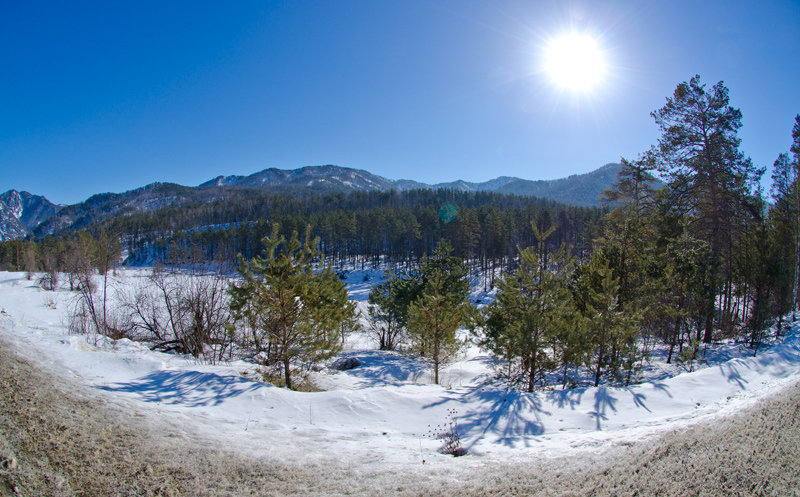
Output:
[200, 163, 620, 206]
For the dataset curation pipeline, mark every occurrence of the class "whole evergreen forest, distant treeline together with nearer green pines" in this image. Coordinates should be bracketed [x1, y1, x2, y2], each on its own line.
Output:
[0, 76, 800, 391]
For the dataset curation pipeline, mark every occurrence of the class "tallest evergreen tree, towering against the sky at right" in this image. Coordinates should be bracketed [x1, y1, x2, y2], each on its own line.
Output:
[652, 76, 764, 342]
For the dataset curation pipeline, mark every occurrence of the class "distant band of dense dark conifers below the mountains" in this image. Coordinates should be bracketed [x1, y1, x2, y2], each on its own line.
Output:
[0, 189, 604, 278]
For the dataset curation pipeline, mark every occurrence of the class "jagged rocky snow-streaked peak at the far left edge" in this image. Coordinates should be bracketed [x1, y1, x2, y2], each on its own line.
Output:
[0, 190, 61, 241]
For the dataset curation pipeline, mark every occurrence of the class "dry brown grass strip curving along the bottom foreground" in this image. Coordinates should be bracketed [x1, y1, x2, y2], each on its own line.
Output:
[0, 331, 800, 497]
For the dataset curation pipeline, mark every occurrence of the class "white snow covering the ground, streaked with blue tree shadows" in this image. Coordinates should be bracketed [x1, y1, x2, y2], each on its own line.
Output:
[0, 270, 800, 467]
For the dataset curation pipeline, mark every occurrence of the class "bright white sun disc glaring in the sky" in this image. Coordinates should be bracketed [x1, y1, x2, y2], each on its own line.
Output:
[545, 34, 604, 90]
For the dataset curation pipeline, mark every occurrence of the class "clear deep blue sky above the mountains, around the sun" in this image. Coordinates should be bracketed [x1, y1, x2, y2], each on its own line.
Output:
[0, 0, 800, 203]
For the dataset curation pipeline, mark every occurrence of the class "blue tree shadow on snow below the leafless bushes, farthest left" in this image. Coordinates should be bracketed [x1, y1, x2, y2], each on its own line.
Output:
[98, 371, 263, 407]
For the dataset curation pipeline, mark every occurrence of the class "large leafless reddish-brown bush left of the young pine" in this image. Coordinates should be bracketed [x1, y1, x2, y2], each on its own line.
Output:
[123, 266, 233, 363]
